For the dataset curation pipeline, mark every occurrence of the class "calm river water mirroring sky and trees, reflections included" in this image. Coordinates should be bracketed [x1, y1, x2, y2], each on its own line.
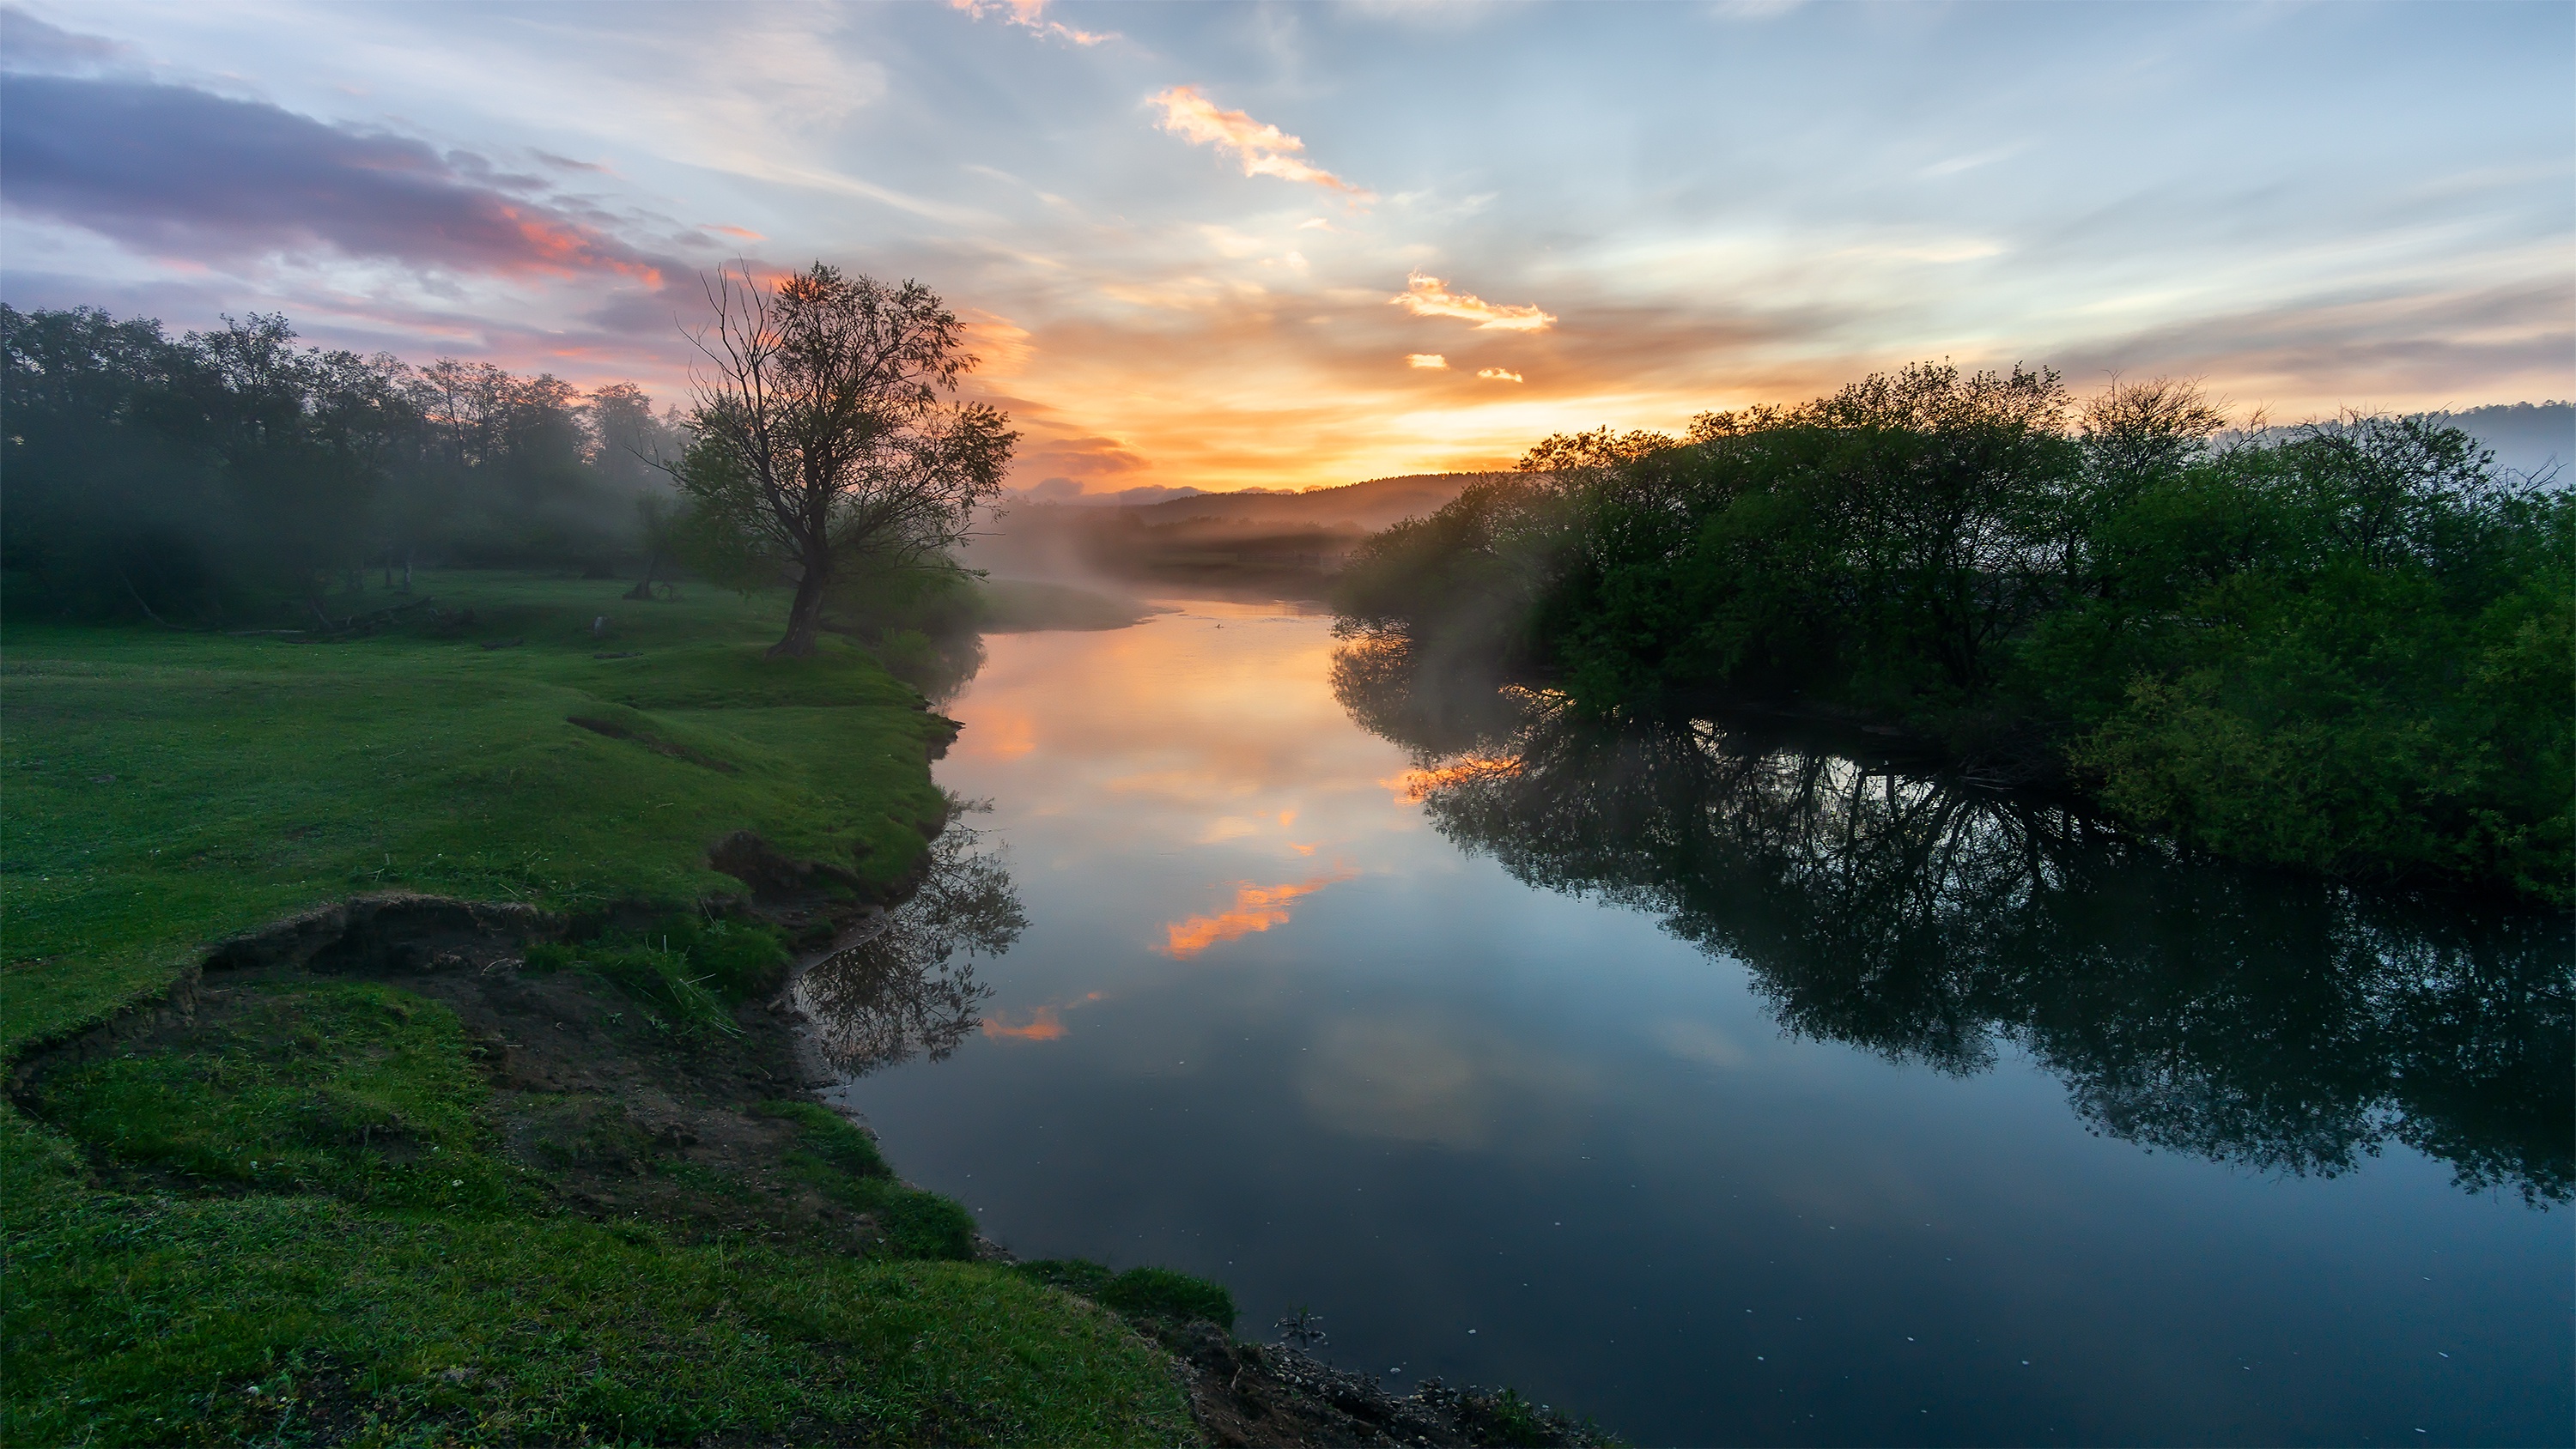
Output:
[809, 600, 2576, 1444]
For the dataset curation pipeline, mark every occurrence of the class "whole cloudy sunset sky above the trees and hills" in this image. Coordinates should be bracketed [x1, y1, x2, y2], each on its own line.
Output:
[0, 0, 2576, 494]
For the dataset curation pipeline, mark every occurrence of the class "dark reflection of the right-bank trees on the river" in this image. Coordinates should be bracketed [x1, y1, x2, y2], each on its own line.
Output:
[1334, 636, 2576, 1207]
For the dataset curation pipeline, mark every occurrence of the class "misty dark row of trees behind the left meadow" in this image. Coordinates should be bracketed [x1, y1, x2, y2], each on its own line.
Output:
[0, 304, 677, 626]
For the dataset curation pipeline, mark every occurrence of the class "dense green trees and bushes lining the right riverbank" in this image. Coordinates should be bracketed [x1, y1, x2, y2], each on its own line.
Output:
[1337, 363, 2576, 900]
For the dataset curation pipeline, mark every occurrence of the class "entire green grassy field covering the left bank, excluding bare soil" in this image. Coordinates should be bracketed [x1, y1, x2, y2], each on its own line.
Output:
[0, 574, 1195, 1444]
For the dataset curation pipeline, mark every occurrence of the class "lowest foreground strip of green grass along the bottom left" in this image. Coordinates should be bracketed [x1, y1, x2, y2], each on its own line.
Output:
[5, 1197, 1193, 1444]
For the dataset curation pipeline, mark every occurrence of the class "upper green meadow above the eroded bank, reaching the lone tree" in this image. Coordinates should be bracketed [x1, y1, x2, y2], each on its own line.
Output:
[0, 574, 943, 1045]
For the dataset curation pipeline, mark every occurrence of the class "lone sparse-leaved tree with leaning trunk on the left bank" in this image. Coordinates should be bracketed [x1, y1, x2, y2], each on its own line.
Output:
[672, 263, 1020, 657]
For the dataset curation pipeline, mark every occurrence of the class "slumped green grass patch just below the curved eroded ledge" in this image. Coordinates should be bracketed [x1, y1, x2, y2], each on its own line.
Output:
[33, 983, 526, 1212]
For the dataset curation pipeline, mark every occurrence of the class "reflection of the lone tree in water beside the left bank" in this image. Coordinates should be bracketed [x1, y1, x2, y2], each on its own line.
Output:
[793, 803, 1028, 1076]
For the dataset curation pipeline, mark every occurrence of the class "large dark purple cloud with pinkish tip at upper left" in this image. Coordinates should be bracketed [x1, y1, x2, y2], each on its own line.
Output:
[0, 75, 680, 288]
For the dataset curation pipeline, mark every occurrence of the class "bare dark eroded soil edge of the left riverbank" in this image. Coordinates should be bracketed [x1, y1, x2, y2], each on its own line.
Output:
[5, 841, 1615, 1446]
